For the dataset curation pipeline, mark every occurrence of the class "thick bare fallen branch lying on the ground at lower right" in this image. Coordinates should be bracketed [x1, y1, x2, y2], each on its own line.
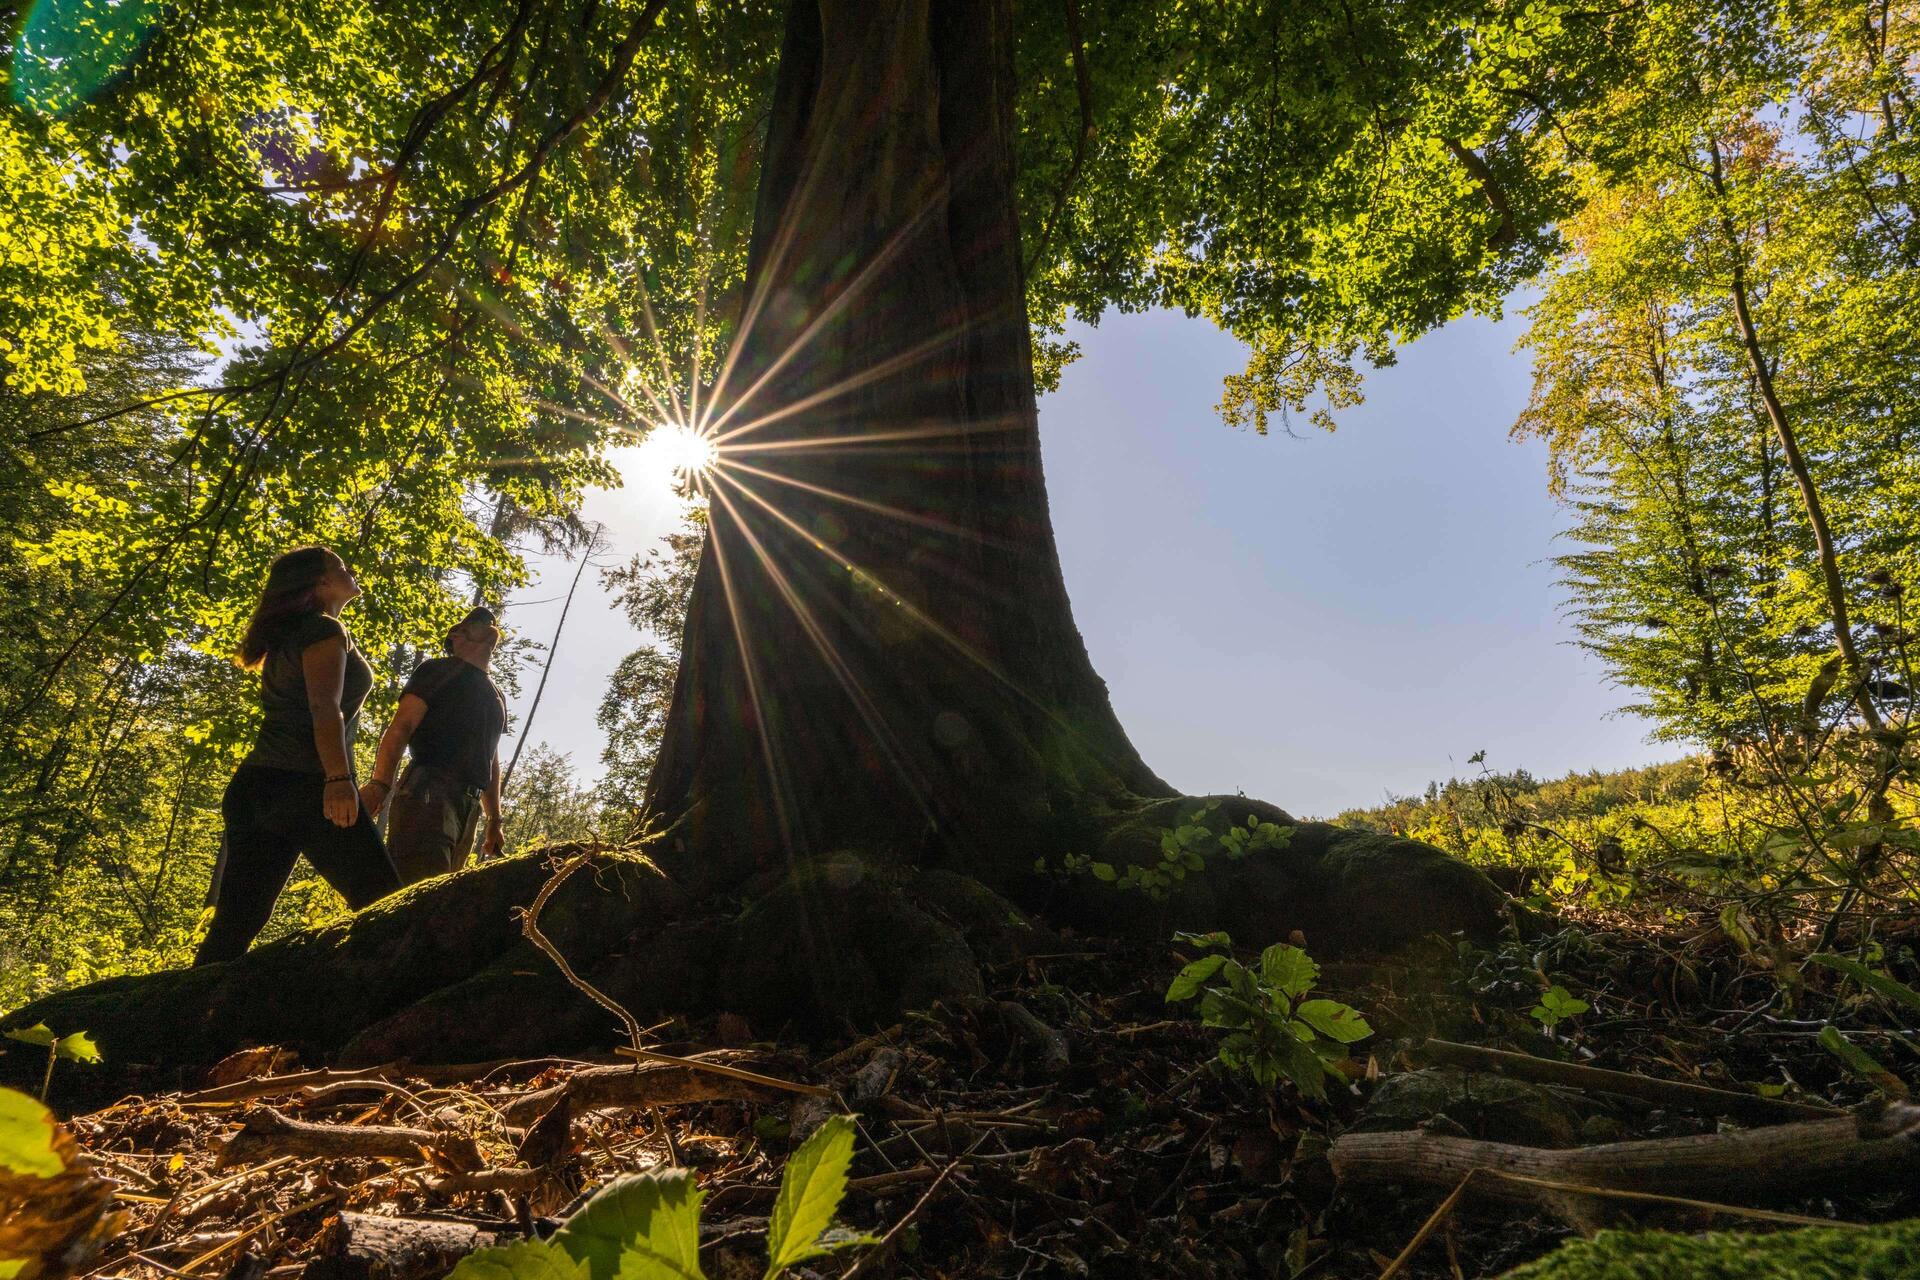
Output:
[1329, 1103, 1920, 1207]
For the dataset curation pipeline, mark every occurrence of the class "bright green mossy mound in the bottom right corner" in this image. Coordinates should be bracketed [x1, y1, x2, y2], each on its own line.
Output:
[1503, 1219, 1920, 1280]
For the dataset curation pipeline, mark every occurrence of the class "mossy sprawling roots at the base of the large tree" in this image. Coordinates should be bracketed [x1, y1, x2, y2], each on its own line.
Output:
[0, 796, 1509, 1102]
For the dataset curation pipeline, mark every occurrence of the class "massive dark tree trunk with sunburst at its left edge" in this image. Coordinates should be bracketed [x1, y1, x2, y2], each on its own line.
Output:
[649, 0, 1171, 901]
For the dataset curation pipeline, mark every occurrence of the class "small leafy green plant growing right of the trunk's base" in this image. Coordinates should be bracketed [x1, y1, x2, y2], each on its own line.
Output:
[1167, 933, 1373, 1098]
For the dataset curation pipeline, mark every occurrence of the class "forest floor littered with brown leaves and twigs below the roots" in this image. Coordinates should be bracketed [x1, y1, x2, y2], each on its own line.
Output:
[26, 875, 1920, 1280]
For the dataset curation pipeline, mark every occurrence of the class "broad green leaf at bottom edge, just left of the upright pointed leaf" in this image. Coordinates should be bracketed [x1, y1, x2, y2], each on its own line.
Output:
[553, 1169, 705, 1280]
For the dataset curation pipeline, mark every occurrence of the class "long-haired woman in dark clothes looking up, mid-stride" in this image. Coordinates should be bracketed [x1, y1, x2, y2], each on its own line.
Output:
[194, 547, 399, 965]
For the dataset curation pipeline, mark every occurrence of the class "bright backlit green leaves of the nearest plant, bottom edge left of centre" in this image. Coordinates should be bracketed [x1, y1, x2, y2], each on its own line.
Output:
[447, 1115, 874, 1280]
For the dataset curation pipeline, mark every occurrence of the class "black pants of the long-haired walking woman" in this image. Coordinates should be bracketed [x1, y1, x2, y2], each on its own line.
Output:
[194, 764, 399, 965]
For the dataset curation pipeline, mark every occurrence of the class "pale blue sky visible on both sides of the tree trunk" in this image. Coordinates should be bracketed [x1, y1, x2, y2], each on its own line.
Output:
[503, 313, 1678, 814]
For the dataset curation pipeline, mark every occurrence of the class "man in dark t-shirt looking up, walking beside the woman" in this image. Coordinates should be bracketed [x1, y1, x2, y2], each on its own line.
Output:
[361, 608, 507, 885]
